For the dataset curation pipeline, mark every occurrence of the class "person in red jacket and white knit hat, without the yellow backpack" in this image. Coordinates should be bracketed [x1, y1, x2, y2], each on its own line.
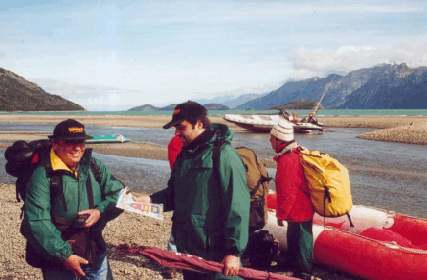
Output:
[270, 119, 314, 277]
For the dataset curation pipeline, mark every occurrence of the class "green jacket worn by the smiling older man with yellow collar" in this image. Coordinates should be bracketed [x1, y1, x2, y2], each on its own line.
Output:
[21, 149, 123, 263]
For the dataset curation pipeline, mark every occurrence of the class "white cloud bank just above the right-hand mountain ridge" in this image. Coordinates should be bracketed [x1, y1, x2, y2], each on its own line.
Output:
[292, 40, 427, 79]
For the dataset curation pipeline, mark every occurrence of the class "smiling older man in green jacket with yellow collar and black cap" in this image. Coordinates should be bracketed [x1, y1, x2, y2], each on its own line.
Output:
[21, 119, 123, 279]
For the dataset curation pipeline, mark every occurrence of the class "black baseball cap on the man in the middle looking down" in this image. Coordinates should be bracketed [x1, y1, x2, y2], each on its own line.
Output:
[163, 101, 208, 129]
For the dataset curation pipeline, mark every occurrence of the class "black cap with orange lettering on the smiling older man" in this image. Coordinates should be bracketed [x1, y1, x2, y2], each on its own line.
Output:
[49, 119, 92, 142]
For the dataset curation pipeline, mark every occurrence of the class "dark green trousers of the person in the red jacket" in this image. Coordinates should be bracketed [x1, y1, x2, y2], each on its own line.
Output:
[286, 221, 313, 273]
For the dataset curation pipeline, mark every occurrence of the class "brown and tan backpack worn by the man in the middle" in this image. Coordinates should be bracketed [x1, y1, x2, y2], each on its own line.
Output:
[213, 143, 271, 232]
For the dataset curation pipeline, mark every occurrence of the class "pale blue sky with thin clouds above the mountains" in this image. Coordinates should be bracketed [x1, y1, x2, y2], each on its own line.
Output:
[0, 0, 427, 111]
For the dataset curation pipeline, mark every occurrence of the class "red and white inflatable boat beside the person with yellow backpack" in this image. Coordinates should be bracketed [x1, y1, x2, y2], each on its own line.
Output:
[266, 194, 427, 280]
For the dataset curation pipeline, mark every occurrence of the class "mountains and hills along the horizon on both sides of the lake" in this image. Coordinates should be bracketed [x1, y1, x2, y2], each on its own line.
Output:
[0, 63, 427, 111]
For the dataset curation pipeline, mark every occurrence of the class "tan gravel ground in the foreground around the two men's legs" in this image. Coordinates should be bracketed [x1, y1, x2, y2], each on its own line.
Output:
[0, 184, 182, 280]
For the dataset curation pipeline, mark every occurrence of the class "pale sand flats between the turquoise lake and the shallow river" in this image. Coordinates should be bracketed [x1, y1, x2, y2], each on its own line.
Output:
[0, 114, 427, 145]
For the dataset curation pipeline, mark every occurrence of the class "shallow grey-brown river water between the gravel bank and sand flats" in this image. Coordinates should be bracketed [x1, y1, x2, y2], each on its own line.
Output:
[0, 124, 427, 218]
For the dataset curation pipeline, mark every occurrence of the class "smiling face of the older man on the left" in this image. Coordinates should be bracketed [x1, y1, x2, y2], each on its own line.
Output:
[53, 140, 85, 168]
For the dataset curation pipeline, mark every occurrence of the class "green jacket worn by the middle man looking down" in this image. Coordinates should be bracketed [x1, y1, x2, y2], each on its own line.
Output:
[152, 124, 249, 260]
